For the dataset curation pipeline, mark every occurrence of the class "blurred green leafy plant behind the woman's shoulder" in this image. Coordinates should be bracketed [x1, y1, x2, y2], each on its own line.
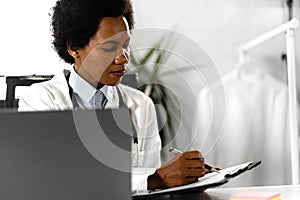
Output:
[130, 34, 178, 149]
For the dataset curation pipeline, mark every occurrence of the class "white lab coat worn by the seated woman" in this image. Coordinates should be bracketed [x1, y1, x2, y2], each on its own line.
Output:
[18, 72, 161, 192]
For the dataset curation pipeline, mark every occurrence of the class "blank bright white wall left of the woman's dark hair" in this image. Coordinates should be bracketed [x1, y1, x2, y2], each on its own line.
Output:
[0, 0, 65, 99]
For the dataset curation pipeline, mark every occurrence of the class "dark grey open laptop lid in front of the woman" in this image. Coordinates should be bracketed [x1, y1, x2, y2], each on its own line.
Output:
[0, 108, 132, 200]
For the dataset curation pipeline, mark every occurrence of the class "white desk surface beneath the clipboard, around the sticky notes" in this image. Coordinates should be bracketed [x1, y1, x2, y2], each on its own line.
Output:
[136, 185, 300, 200]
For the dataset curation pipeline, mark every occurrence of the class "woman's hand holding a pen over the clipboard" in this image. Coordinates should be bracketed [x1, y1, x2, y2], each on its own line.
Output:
[148, 151, 207, 190]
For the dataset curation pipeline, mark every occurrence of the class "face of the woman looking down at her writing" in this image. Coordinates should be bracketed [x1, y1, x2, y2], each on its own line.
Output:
[69, 16, 130, 87]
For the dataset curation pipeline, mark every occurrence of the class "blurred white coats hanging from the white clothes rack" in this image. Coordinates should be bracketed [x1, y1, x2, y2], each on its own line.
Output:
[191, 69, 291, 186]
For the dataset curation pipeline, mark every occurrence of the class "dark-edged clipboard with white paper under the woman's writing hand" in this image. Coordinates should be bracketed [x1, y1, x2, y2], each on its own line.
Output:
[133, 161, 261, 199]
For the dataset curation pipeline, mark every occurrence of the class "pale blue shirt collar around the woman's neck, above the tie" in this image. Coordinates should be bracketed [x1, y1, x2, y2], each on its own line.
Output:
[69, 68, 113, 102]
